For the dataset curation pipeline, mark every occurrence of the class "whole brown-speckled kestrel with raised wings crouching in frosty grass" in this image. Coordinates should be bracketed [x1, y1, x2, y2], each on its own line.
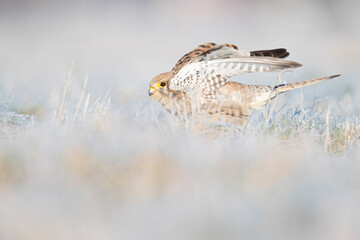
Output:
[148, 43, 340, 125]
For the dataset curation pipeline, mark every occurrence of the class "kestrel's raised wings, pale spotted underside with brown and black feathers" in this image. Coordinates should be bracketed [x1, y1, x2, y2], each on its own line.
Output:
[170, 43, 301, 96]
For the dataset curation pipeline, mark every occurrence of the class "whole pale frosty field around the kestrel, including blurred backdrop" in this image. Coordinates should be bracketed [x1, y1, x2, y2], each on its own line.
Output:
[0, 0, 360, 240]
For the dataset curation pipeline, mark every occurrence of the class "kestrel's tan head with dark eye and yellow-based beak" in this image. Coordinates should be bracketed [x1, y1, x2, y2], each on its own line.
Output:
[148, 72, 171, 101]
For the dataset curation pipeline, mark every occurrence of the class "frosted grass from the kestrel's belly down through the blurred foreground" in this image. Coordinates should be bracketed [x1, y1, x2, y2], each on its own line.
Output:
[0, 74, 360, 239]
